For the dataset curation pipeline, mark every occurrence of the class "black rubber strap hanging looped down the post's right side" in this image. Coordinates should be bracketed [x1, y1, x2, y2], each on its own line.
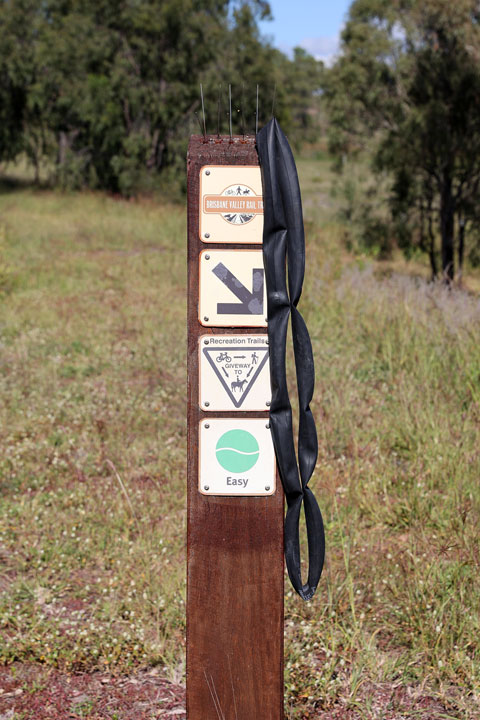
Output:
[257, 118, 325, 600]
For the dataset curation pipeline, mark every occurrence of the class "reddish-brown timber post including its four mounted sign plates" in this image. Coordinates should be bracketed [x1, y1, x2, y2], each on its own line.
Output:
[187, 136, 284, 720]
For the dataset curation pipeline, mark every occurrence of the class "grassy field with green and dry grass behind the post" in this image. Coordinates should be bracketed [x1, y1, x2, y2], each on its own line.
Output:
[0, 160, 480, 720]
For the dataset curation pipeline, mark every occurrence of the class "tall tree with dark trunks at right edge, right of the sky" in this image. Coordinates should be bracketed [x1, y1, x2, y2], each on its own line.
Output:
[326, 0, 480, 281]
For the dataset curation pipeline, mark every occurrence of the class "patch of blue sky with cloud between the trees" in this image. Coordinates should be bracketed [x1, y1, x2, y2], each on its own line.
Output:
[260, 0, 351, 64]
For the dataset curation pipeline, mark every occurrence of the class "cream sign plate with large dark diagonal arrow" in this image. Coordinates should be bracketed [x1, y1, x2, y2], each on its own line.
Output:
[198, 250, 267, 327]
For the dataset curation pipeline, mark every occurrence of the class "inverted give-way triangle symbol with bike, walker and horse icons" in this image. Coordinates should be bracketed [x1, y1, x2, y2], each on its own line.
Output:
[203, 345, 268, 408]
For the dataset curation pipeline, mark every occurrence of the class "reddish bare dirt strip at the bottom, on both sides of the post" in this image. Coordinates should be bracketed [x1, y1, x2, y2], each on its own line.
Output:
[0, 664, 454, 720]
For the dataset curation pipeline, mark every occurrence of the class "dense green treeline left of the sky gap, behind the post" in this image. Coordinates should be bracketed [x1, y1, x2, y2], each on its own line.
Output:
[0, 0, 322, 195]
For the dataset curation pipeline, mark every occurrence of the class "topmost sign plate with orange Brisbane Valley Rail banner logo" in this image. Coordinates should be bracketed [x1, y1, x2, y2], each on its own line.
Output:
[200, 165, 263, 244]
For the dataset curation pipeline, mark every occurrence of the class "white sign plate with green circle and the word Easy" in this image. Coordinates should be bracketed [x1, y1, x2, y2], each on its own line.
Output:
[199, 418, 275, 495]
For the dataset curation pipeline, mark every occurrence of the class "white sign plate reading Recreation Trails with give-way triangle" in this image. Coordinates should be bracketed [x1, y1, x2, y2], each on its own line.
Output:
[198, 335, 271, 411]
